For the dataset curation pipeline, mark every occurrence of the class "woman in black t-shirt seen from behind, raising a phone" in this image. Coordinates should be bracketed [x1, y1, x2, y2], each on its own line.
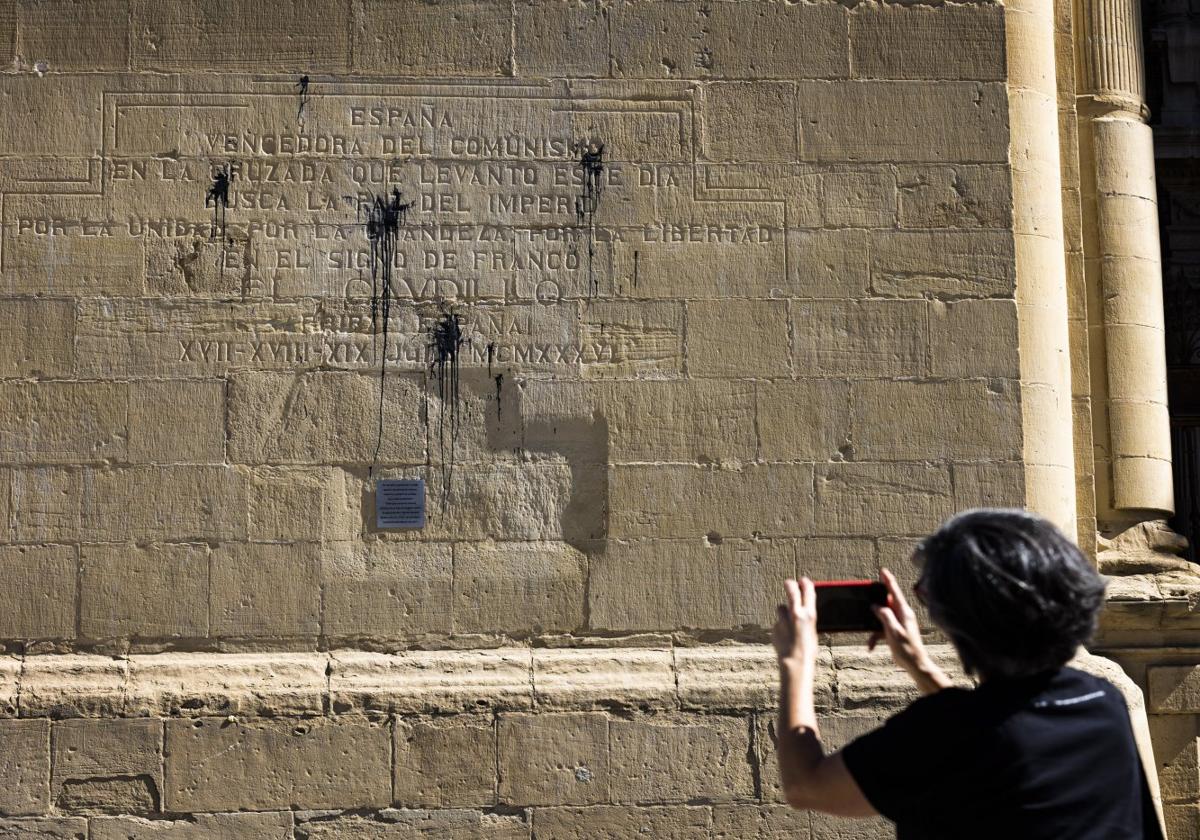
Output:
[773, 510, 1162, 840]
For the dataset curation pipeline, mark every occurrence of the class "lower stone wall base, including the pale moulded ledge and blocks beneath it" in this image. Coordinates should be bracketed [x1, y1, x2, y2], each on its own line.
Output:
[0, 646, 953, 840]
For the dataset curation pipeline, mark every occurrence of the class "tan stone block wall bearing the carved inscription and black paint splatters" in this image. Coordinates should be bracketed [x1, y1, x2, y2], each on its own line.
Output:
[0, 0, 1028, 840]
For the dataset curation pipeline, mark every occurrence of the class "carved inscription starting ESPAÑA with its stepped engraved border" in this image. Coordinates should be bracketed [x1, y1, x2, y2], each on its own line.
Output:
[7, 78, 787, 364]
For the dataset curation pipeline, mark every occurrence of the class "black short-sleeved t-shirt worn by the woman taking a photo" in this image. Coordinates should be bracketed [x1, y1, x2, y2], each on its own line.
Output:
[842, 668, 1162, 840]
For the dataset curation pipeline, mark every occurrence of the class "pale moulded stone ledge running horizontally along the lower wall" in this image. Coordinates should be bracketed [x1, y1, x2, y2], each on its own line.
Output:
[0, 644, 958, 718]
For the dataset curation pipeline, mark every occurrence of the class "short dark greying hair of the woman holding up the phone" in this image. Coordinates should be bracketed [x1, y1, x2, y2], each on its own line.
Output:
[914, 509, 1104, 679]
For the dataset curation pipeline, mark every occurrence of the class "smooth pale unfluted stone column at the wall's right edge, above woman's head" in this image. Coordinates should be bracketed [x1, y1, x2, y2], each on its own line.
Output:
[1004, 0, 1075, 534]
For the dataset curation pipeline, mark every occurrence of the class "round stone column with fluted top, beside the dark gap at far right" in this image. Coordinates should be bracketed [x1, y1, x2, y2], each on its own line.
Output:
[1075, 0, 1177, 571]
